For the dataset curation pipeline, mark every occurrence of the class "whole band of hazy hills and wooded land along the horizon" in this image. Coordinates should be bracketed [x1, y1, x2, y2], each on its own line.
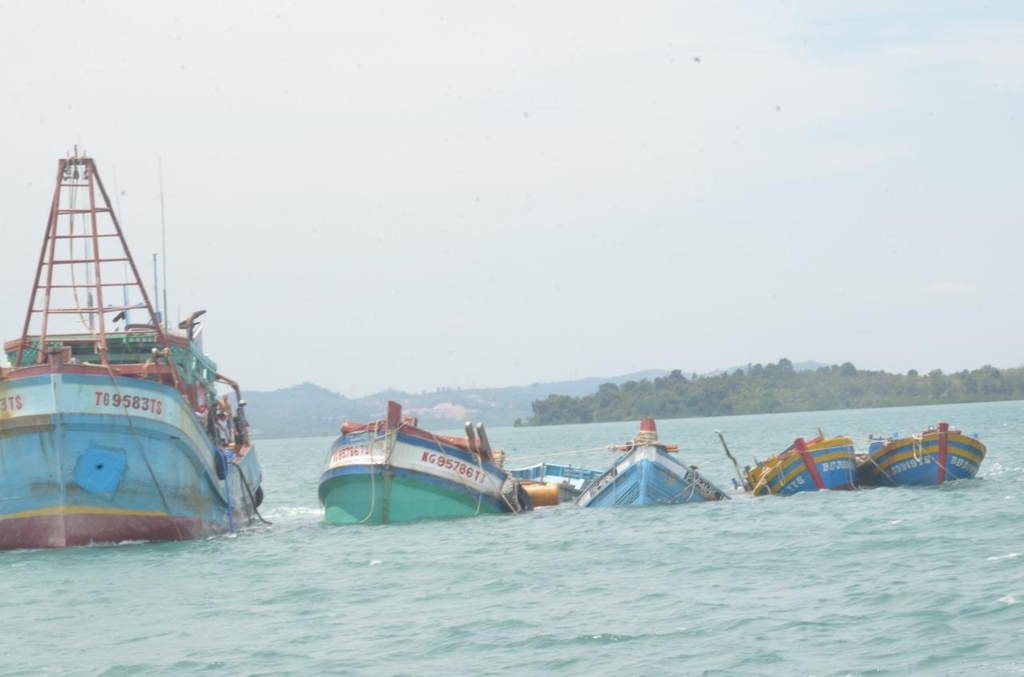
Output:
[232, 359, 1024, 438]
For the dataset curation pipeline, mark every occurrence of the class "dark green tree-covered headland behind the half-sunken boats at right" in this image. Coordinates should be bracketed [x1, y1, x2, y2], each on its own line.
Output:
[516, 358, 1024, 426]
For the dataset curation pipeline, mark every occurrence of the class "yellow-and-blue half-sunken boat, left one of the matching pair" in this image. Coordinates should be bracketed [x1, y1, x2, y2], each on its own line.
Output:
[744, 434, 856, 496]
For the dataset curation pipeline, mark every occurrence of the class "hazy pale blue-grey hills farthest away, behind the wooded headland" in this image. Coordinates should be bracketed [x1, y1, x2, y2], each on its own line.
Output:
[245, 370, 669, 438]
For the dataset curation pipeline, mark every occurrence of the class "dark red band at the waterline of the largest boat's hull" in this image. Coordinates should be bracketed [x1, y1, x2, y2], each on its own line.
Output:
[0, 514, 227, 550]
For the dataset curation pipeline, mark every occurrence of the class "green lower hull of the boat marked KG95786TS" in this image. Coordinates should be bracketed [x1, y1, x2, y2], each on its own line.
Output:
[319, 473, 503, 524]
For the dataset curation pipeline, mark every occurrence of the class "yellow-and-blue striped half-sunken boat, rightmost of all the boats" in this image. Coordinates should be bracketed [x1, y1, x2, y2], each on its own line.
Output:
[857, 422, 986, 486]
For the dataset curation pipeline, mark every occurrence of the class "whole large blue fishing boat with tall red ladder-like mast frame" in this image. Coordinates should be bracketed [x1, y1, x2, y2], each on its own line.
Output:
[0, 150, 263, 549]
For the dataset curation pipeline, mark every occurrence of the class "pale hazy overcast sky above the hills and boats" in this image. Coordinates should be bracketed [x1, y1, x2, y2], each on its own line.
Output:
[0, 0, 1024, 397]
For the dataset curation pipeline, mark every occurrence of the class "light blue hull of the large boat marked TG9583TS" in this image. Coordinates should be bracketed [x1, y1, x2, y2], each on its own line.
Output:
[0, 370, 261, 549]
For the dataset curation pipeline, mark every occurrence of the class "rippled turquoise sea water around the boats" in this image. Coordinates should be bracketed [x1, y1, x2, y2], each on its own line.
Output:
[0, 403, 1024, 675]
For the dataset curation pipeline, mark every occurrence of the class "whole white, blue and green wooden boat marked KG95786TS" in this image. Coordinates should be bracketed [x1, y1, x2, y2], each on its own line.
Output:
[318, 401, 532, 524]
